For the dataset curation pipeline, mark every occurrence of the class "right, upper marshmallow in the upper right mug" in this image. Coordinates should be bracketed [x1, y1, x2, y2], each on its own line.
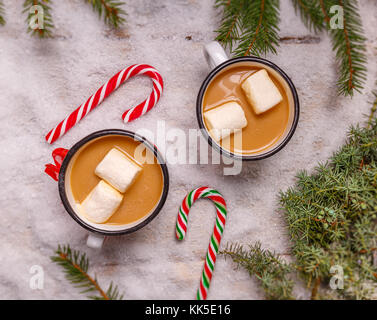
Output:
[242, 69, 283, 114]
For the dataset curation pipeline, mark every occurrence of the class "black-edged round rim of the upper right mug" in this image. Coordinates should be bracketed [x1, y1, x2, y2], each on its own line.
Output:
[196, 56, 300, 161]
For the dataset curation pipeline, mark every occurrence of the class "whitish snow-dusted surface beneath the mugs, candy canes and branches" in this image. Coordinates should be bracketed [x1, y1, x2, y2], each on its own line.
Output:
[0, 0, 377, 299]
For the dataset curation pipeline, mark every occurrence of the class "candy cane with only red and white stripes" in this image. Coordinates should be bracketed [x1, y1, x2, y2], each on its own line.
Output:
[46, 64, 164, 144]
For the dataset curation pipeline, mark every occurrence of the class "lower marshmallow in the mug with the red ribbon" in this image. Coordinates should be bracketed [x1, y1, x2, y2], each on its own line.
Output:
[78, 180, 123, 223]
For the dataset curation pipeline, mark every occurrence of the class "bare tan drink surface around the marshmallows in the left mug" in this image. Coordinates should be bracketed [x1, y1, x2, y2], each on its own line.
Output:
[71, 135, 164, 225]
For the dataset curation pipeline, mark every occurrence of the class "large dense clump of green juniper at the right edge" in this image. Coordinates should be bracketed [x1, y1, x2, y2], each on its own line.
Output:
[281, 112, 377, 299]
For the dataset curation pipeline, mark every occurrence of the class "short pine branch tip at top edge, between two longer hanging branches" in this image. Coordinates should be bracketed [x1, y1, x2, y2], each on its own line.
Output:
[292, 0, 325, 33]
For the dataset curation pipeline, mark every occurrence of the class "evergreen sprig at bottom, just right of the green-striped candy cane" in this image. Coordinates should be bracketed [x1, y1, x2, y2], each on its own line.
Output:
[220, 242, 293, 299]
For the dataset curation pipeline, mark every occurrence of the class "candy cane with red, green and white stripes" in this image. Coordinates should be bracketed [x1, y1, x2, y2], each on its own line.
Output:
[175, 187, 227, 300]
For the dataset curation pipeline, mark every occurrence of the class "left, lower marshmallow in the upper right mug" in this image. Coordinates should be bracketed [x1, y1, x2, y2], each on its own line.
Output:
[204, 101, 247, 142]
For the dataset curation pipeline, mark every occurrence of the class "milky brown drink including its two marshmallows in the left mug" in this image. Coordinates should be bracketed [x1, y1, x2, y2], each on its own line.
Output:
[70, 135, 164, 225]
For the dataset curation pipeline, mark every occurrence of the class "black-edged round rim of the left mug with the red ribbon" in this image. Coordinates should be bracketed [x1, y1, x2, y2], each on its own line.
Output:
[58, 129, 169, 236]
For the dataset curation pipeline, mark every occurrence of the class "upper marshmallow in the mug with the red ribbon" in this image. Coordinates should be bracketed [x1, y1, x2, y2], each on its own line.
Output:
[95, 148, 142, 193]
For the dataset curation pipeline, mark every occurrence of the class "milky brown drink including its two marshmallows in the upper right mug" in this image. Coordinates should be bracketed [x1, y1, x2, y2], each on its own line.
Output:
[202, 63, 290, 155]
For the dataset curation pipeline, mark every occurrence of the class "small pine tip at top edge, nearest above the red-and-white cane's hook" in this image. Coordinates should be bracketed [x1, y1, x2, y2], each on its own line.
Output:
[85, 0, 126, 28]
